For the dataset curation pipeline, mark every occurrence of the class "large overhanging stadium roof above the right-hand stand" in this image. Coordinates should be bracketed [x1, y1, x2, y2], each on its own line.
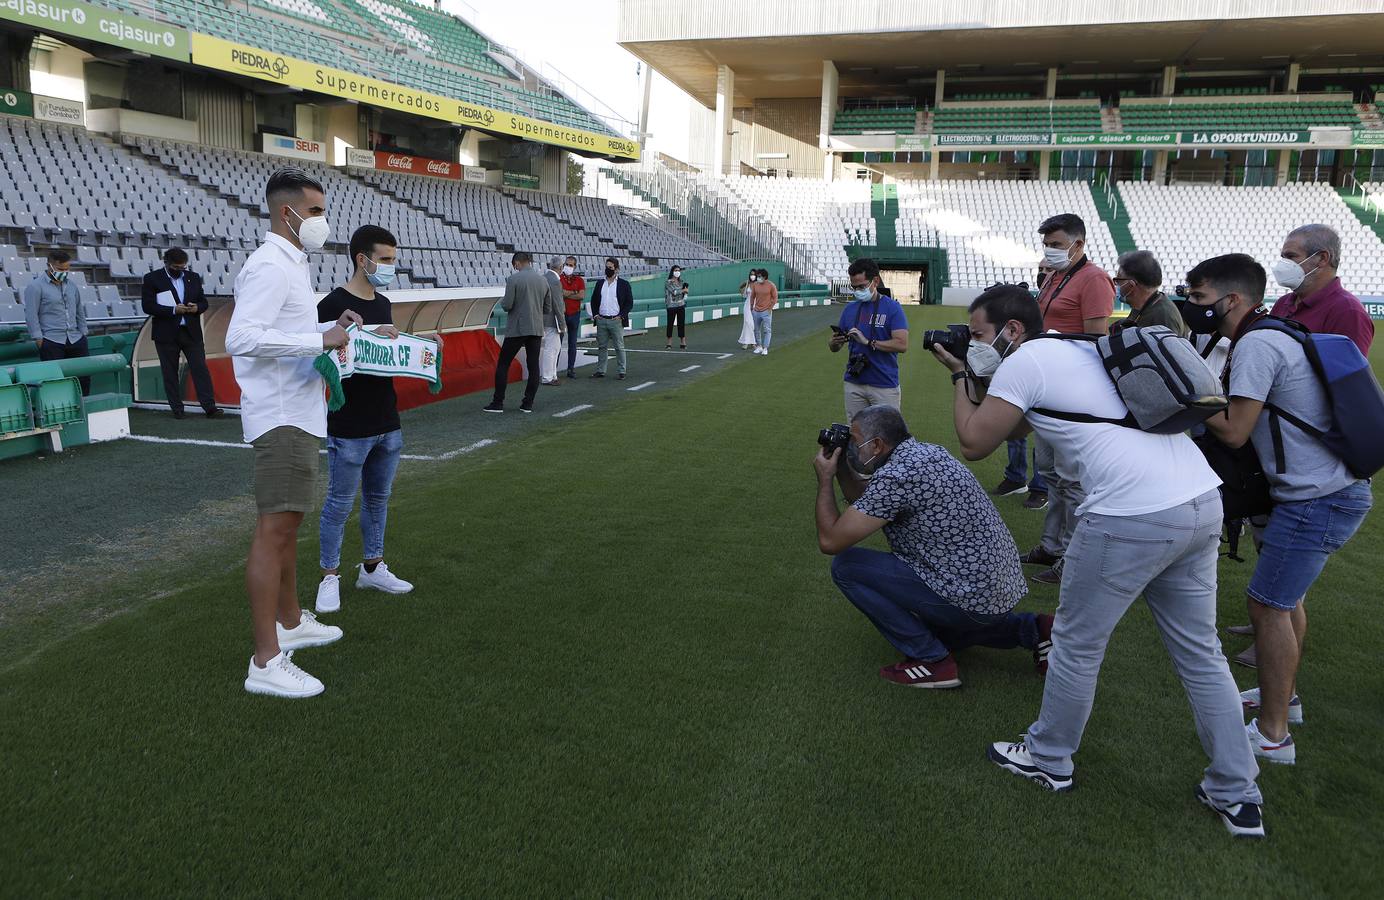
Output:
[619, 0, 1384, 105]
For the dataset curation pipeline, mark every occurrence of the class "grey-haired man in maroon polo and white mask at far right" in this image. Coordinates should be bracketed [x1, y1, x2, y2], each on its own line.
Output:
[1272, 224, 1374, 356]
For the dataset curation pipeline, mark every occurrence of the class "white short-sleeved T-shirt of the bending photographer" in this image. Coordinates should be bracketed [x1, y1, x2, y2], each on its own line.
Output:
[988, 341, 1221, 515]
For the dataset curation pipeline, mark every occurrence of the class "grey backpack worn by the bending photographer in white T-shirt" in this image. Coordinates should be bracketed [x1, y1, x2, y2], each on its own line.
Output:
[1034, 325, 1229, 435]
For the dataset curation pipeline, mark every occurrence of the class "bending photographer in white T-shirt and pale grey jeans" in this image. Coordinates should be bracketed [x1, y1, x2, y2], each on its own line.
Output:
[933, 285, 1264, 836]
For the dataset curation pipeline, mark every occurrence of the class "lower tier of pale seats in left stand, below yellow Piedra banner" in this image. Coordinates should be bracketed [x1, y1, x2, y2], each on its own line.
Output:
[0, 116, 725, 323]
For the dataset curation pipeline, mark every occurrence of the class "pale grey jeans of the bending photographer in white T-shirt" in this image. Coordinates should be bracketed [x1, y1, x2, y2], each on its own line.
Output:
[1027, 490, 1262, 804]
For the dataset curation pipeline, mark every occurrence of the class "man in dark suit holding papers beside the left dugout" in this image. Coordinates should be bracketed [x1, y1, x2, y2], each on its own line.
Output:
[141, 246, 224, 418]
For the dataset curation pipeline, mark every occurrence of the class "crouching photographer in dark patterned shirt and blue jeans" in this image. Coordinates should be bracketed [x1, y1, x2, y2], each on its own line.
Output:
[812, 406, 1052, 688]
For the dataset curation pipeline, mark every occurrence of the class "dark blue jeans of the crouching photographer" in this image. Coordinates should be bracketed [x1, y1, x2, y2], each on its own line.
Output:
[832, 547, 1038, 662]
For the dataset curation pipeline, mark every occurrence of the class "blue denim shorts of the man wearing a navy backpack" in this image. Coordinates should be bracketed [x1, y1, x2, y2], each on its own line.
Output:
[1248, 480, 1372, 609]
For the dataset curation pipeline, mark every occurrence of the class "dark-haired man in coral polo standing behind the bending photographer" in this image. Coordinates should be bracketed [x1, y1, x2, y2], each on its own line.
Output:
[1020, 213, 1116, 584]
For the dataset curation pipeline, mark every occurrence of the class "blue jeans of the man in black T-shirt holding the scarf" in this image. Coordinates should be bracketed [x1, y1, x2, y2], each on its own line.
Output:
[318, 429, 404, 569]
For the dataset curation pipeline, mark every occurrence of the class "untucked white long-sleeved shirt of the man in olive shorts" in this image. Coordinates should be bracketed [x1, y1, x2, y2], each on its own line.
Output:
[226, 234, 336, 442]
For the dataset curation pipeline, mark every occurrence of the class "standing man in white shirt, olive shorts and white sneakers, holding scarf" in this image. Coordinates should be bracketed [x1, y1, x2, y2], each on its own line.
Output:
[226, 169, 361, 696]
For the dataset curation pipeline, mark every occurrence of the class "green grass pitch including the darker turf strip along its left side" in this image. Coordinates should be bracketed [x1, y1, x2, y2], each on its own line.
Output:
[0, 309, 1384, 897]
